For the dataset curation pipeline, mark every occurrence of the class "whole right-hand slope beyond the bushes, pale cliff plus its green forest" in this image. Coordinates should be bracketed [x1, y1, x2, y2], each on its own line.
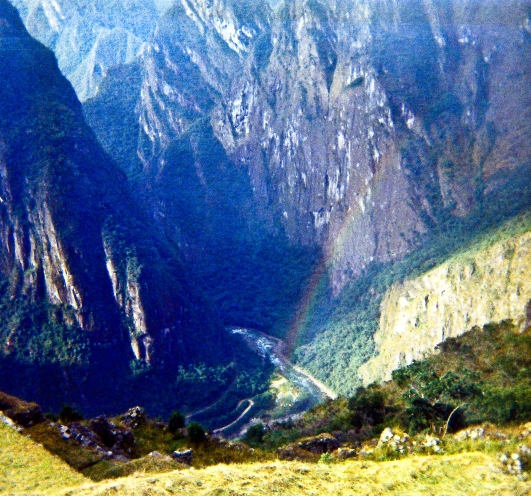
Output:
[295, 213, 531, 396]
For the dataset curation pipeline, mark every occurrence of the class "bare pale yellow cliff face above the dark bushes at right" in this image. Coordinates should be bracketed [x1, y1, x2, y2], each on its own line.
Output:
[360, 225, 531, 384]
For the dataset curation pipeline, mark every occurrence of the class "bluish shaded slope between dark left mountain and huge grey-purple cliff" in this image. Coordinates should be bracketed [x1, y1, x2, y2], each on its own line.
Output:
[84, 0, 319, 333]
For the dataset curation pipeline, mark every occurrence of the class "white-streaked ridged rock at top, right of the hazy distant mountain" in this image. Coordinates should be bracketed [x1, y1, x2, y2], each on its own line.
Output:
[139, 0, 269, 162]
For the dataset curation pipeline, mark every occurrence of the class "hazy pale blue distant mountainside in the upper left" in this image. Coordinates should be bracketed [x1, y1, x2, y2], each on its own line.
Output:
[8, 0, 162, 101]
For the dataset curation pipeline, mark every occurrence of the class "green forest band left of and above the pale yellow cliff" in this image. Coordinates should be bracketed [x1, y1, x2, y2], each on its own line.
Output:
[294, 207, 531, 396]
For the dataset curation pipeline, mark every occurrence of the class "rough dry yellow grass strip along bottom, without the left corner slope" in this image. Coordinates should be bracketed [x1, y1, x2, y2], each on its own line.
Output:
[56, 453, 531, 496]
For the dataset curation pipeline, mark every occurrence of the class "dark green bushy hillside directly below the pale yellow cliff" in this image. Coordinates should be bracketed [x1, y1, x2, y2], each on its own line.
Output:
[272, 321, 531, 448]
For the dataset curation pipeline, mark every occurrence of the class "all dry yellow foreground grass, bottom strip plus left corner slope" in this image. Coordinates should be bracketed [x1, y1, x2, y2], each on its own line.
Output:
[0, 425, 531, 496]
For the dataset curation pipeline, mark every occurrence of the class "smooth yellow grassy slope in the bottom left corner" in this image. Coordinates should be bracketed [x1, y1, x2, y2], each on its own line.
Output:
[0, 423, 86, 494]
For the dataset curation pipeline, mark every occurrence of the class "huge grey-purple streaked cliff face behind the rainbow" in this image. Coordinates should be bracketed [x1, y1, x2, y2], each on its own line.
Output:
[212, 0, 531, 291]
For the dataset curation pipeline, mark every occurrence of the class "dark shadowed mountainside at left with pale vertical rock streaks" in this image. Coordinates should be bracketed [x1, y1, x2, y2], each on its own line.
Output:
[0, 0, 232, 409]
